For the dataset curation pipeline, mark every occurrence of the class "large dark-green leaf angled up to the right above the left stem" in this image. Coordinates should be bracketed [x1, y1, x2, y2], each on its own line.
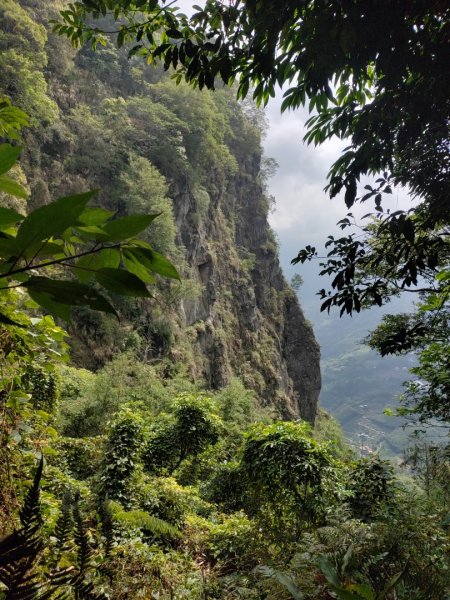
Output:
[16, 191, 96, 252]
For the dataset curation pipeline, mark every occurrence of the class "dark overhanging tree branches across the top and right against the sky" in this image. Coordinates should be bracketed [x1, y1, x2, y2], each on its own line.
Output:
[55, 0, 450, 432]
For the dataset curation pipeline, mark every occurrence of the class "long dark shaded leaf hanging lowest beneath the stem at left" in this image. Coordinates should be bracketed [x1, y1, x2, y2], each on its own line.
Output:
[23, 276, 117, 318]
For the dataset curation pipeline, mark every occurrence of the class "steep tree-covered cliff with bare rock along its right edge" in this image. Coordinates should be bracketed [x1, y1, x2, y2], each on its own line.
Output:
[7, 0, 320, 422]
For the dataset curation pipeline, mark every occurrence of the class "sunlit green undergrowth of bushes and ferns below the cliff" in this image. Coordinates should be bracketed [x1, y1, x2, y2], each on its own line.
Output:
[0, 326, 448, 600]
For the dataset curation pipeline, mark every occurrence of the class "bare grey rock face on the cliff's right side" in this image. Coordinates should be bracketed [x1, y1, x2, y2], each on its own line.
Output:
[172, 155, 321, 423]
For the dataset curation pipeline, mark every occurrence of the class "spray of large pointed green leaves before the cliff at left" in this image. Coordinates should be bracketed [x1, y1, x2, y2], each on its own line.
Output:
[0, 150, 178, 319]
